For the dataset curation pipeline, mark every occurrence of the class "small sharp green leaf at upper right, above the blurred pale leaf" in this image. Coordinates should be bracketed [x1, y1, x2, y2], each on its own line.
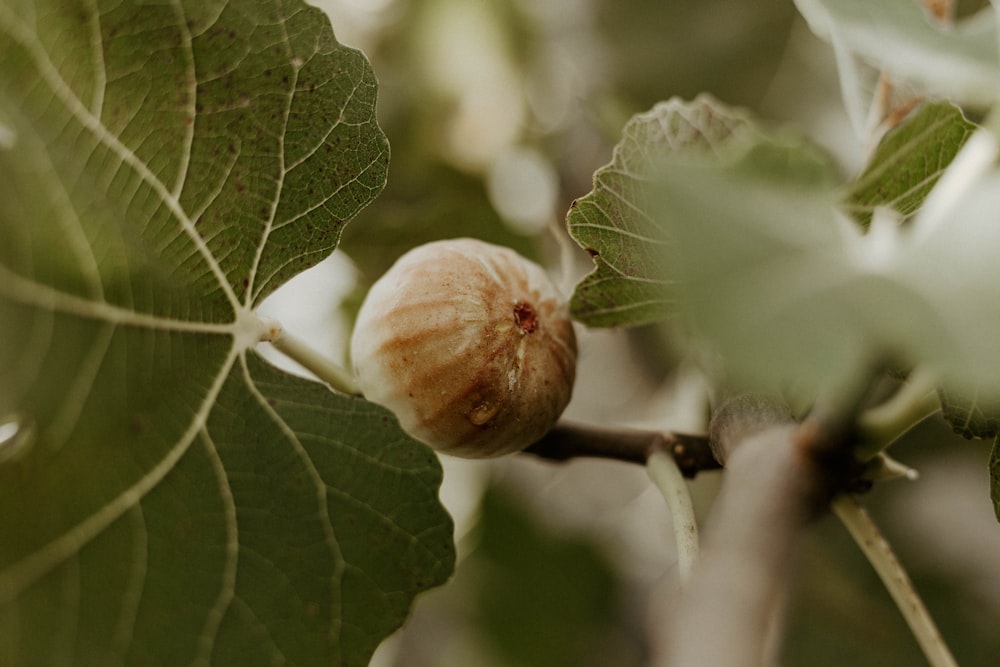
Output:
[847, 102, 976, 228]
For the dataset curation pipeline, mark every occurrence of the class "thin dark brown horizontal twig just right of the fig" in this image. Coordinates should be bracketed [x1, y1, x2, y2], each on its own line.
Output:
[524, 422, 720, 478]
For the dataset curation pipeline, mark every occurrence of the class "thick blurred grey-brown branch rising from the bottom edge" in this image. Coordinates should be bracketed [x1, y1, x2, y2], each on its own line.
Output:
[660, 397, 855, 667]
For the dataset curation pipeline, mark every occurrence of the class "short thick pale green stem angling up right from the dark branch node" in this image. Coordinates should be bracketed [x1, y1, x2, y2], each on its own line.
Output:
[855, 369, 941, 461]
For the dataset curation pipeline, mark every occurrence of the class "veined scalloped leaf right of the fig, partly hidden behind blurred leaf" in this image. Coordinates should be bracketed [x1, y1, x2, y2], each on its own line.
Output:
[567, 95, 833, 327]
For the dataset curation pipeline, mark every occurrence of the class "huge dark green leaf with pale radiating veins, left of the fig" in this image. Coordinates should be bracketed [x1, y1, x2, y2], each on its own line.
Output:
[0, 0, 453, 665]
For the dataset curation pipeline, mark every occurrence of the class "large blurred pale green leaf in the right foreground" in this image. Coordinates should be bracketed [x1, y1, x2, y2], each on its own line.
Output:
[661, 136, 1000, 401]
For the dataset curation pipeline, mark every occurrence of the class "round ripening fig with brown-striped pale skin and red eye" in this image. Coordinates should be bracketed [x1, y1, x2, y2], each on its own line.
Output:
[351, 239, 576, 458]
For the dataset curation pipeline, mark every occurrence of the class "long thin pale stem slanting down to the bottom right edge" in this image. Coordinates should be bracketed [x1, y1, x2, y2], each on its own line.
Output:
[831, 495, 957, 667]
